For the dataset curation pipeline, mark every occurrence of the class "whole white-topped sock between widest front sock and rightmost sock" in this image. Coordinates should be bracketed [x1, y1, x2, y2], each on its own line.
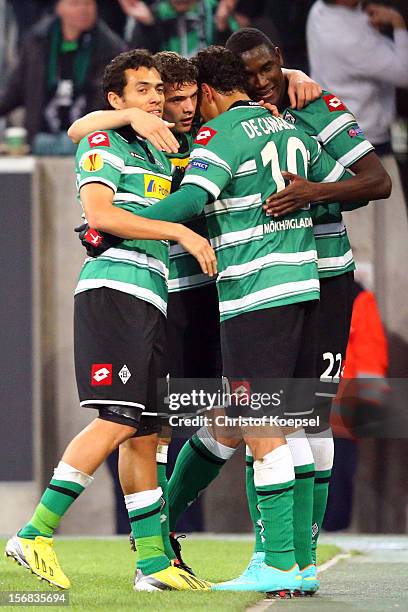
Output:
[286, 429, 315, 570]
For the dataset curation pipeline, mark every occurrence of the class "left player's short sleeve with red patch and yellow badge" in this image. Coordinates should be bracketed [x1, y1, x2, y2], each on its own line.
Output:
[76, 132, 125, 193]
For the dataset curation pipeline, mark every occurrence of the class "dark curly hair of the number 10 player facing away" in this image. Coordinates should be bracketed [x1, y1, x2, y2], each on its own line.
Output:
[192, 45, 248, 94]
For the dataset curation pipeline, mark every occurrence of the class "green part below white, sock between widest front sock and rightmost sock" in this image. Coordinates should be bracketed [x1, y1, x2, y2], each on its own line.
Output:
[293, 463, 315, 570]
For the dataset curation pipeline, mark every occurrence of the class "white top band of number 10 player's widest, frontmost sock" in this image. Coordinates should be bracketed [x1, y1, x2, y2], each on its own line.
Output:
[254, 444, 295, 487]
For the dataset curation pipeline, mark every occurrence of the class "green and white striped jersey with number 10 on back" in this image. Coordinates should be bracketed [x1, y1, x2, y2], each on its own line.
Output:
[182, 101, 344, 321]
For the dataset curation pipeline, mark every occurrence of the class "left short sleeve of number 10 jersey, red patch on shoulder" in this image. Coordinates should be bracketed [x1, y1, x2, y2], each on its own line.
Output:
[181, 125, 239, 200]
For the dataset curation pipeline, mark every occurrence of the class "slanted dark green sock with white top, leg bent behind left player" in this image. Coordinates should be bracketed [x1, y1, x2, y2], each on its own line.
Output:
[169, 428, 235, 531]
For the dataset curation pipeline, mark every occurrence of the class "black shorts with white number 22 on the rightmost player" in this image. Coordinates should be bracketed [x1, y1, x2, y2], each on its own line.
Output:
[315, 272, 354, 429]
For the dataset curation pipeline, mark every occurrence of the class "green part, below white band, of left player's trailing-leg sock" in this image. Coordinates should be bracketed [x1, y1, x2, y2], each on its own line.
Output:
[17, 478, 85, 540]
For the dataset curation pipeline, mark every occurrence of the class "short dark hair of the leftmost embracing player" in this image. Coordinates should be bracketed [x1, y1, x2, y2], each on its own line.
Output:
[102, 49, 157, 108]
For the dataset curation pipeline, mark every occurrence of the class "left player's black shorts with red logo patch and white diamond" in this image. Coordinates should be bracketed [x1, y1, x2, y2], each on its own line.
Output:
[74, 287, 167, 435]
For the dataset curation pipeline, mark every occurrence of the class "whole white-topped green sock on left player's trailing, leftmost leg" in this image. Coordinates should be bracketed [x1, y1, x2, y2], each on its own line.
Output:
[17, 461, 93, 540]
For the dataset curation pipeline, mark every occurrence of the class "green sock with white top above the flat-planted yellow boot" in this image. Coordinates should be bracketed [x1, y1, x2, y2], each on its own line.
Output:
[129, 491, 170, 574]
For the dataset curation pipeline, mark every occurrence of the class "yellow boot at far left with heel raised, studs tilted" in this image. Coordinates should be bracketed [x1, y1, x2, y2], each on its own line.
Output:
[4, 535, 71, 589]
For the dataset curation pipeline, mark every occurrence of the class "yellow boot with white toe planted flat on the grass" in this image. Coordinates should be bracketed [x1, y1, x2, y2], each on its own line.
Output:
[134, 565, 212, 591]
